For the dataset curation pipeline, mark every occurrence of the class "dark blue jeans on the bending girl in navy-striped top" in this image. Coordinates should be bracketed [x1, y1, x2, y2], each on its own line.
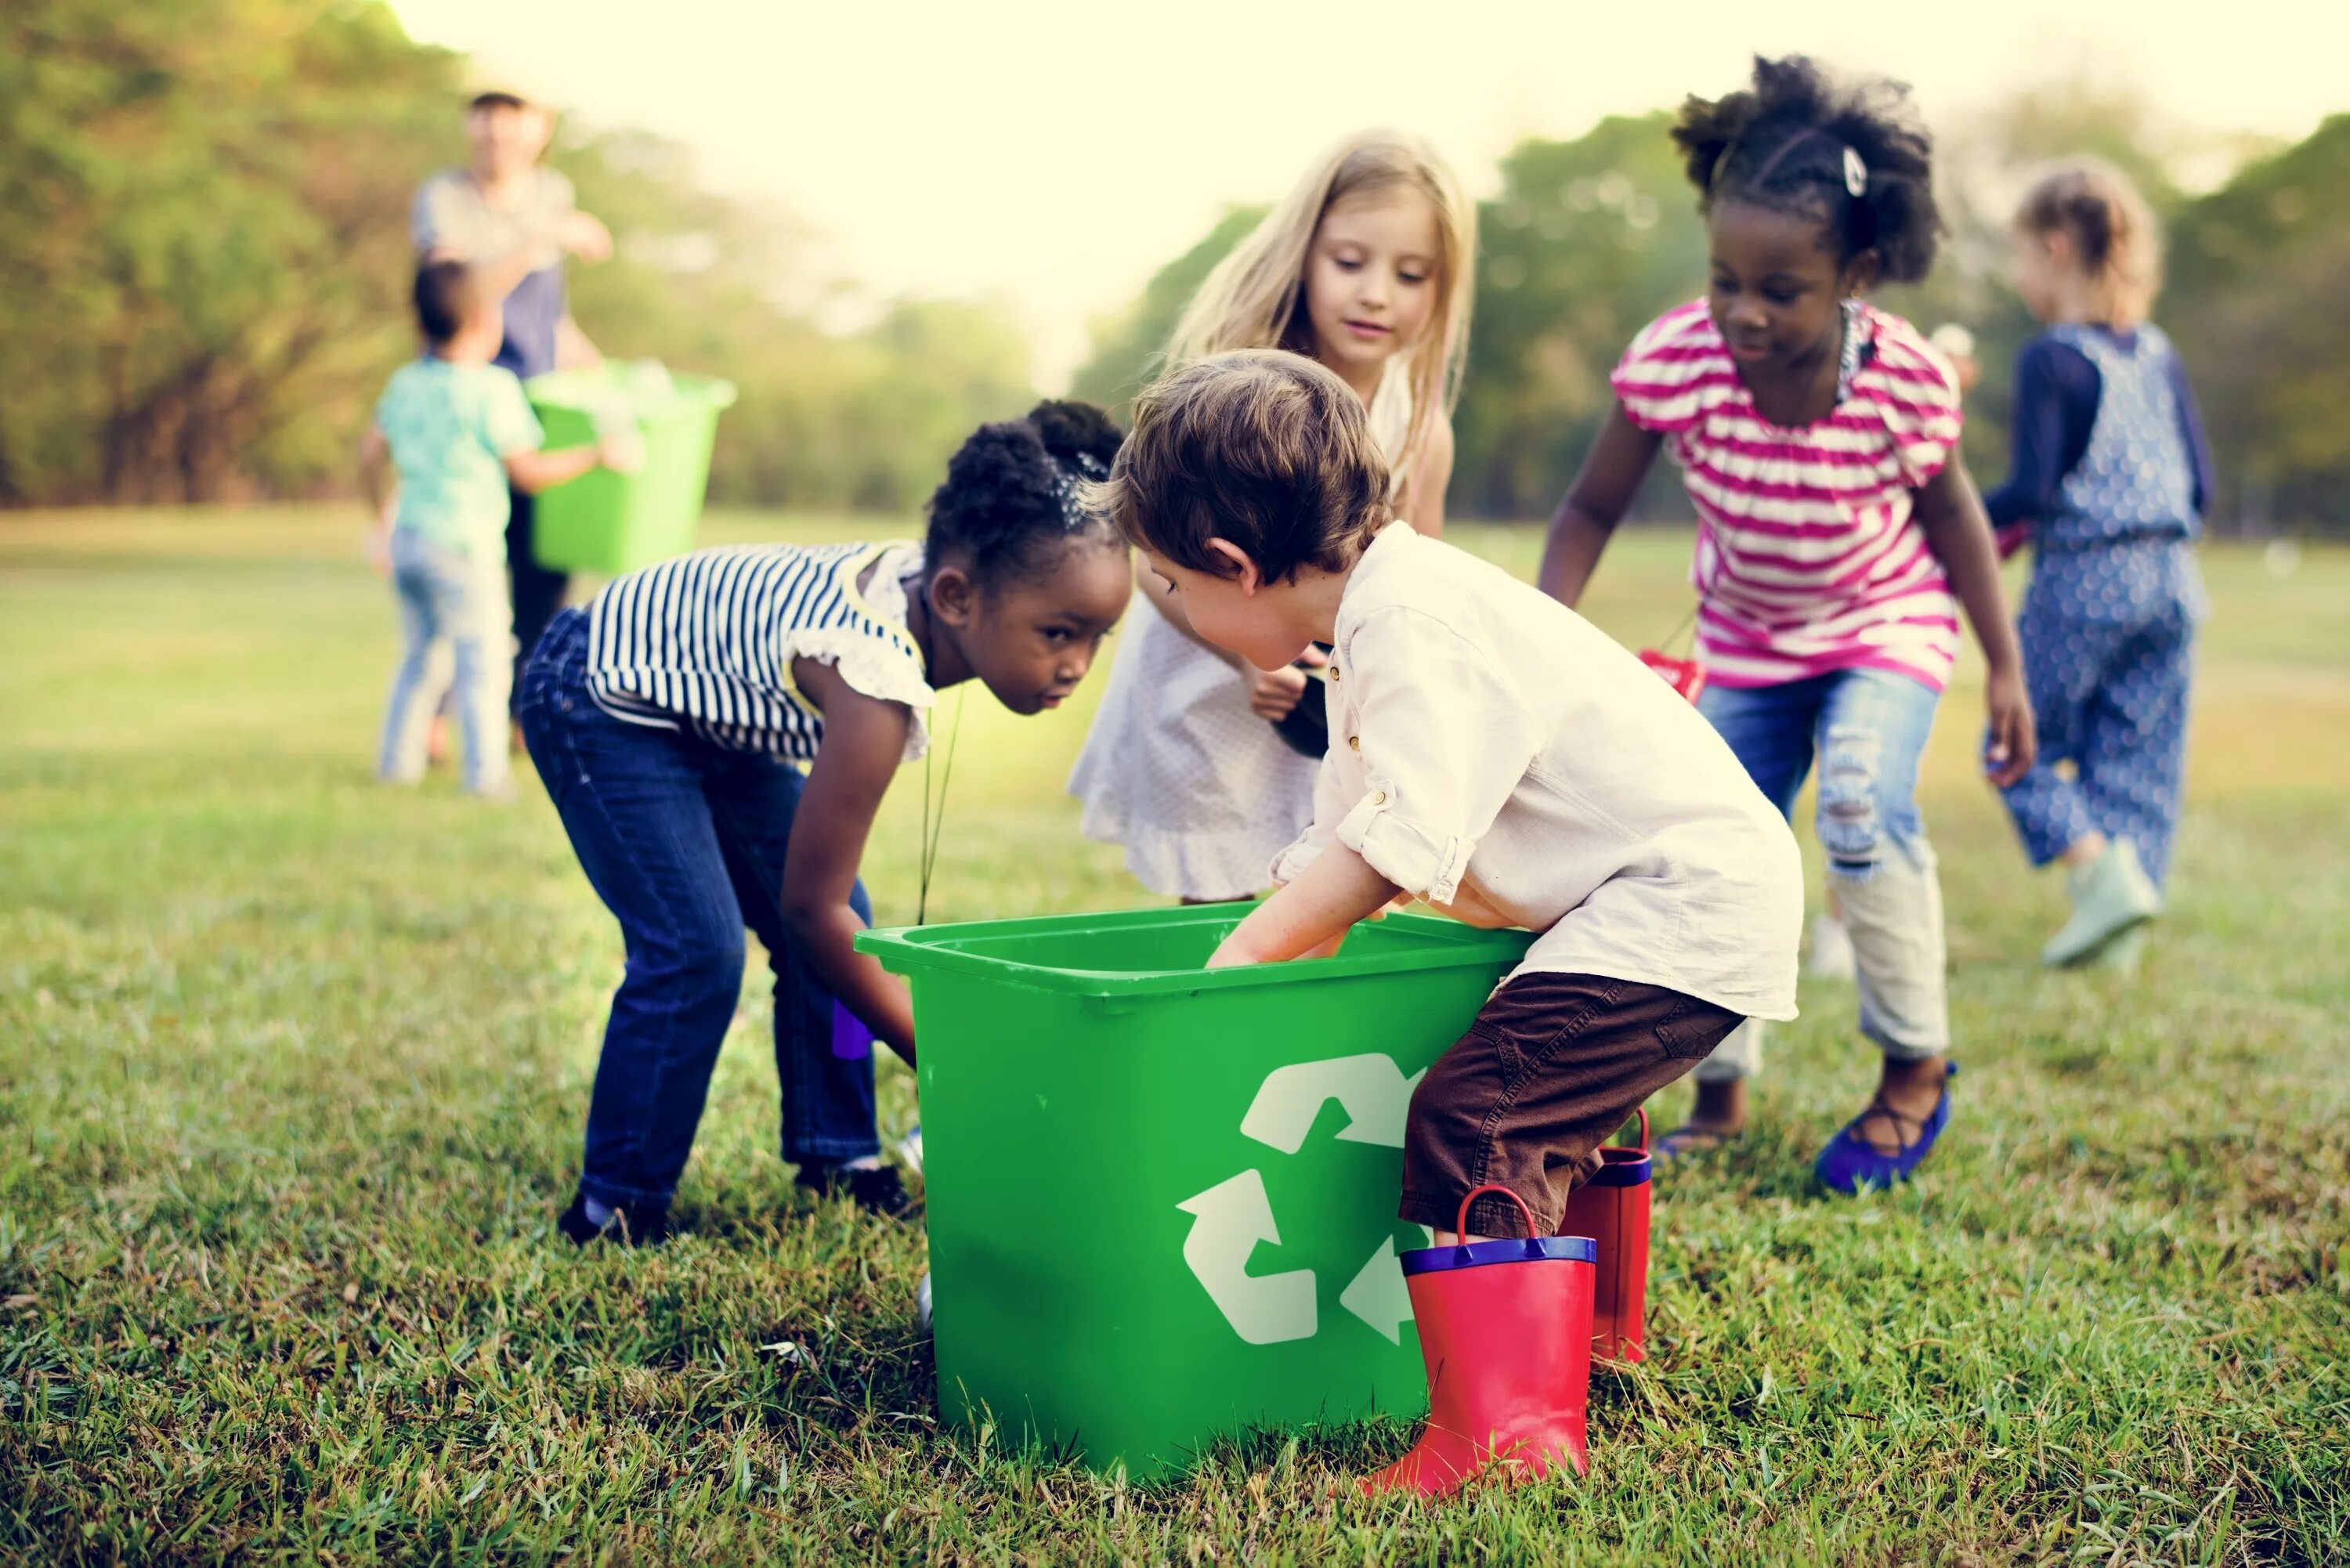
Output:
[519, 609, 881, 1206]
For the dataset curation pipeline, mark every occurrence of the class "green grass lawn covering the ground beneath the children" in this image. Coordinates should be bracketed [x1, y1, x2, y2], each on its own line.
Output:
[0, 510, 2350, 1563]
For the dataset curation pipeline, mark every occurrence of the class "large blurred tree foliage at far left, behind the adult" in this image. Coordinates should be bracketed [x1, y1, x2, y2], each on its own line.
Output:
[0, 0, 456, 500]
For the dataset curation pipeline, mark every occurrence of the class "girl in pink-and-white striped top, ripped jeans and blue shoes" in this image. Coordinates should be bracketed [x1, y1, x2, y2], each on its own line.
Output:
[1542, 56, 2033, 1192]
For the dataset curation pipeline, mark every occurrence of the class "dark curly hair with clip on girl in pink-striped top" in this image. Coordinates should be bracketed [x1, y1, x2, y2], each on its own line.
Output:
[1673, 54, 1941, 282]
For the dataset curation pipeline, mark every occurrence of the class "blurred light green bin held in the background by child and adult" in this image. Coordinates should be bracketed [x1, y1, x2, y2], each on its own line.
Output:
[526, 362, 736, 576]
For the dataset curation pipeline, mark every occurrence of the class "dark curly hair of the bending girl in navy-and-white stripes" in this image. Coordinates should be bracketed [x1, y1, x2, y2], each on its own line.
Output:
[924, 399, 1126, 590]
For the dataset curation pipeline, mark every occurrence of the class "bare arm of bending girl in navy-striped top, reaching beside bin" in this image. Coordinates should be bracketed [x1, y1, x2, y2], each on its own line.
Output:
[780, 658, 914, 1063]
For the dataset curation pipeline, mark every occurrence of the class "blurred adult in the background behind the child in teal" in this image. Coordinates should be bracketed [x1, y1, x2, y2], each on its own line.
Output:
[411, 92, 611, 719]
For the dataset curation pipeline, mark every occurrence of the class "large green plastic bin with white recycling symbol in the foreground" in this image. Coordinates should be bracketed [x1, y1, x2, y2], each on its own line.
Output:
[858, 905, 1532, 1479]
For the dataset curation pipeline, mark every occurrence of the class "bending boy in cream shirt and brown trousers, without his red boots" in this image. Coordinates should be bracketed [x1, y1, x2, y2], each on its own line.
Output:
[1097, 350, 1802, 1244]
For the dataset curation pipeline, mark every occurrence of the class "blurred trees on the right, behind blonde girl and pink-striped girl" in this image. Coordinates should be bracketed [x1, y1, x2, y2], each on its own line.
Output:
[1074, 82, 2350, 536]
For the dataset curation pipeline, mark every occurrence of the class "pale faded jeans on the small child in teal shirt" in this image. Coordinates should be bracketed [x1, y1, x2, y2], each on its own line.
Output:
[376, 529, 512, 795]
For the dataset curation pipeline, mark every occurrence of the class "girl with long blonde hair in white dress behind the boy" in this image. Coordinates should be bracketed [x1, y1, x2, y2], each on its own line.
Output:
[1069, 132, 1476, 903]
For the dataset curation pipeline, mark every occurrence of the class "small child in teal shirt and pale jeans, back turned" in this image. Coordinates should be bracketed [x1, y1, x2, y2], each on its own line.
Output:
[360, 261, 632, 795]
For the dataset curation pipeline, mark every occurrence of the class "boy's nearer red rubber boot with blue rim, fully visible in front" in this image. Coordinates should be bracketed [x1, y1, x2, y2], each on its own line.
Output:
[1363, 1187, 1596, 1498]
